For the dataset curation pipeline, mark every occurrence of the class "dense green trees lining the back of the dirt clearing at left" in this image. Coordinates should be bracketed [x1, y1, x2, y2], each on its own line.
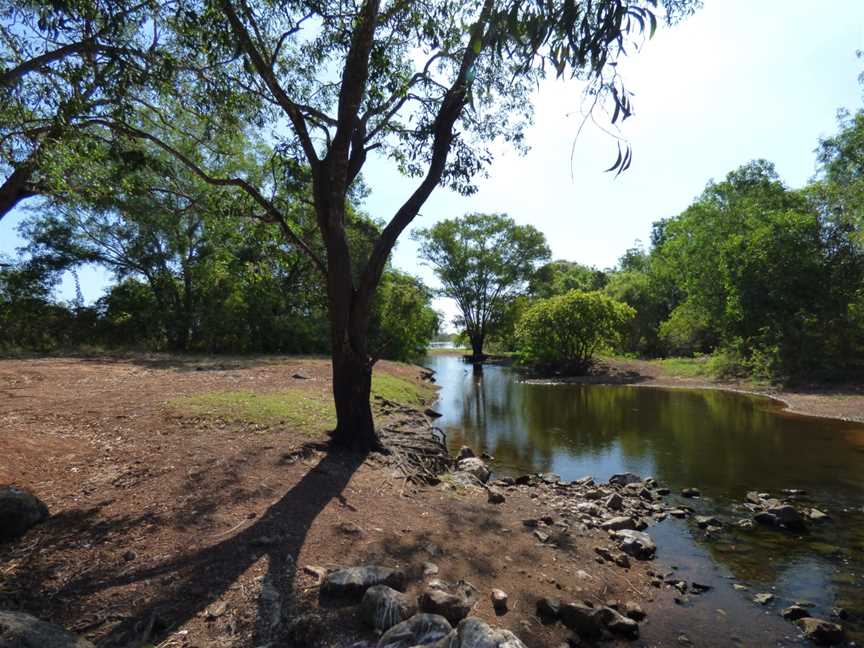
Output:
[0, 142, 438, 359]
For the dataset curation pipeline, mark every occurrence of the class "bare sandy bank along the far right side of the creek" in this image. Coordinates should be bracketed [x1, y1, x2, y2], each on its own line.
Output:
[524, 357, 864, 423]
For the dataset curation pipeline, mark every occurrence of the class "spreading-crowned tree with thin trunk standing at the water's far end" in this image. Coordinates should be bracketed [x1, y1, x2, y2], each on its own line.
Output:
[415, 214, 549, 361]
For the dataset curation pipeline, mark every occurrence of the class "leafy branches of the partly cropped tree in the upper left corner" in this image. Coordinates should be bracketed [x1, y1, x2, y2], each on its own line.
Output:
[0, 0, 170, 220]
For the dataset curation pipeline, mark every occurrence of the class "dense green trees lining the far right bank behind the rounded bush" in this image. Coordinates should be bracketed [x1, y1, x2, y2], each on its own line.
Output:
[490, 113, 864, 380]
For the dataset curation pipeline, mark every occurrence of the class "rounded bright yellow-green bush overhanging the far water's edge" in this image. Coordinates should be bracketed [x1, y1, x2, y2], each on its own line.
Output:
[517, 290, 636, 373]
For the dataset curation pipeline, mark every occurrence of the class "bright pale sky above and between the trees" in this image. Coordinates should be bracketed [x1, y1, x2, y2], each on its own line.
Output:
[0, 0, 864, 330]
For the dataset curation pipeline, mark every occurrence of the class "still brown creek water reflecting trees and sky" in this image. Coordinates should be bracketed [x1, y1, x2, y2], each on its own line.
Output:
[427, 355, 864, 642]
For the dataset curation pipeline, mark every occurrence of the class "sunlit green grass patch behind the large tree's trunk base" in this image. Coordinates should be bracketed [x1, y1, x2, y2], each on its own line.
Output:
[168, 373, 435, 433]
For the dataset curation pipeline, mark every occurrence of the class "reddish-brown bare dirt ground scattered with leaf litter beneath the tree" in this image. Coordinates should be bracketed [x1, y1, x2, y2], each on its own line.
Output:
[0, 357, 788, 648]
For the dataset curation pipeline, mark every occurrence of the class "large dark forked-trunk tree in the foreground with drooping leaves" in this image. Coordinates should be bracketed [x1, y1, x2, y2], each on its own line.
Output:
[27, 0, 697, 448]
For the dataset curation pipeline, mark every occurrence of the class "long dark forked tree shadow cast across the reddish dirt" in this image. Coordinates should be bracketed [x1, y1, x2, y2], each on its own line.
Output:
[55, 450, 366, 648]
